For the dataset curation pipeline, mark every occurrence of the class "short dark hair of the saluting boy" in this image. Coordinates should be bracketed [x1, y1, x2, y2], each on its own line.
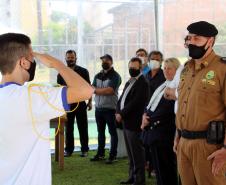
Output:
[0, 33, 31, 75]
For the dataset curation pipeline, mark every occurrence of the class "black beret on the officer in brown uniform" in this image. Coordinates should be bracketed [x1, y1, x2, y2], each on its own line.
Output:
[187, 21, 218, 37]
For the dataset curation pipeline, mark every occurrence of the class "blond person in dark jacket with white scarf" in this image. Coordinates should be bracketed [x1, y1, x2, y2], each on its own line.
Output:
[141, 58, 180, 185]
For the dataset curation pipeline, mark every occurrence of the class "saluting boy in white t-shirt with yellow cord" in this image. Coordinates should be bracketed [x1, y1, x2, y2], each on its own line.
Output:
[0, 33, 93, 185]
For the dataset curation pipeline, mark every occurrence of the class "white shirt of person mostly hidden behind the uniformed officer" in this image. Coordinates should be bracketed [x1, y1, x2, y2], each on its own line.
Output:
[168, 65, 184, 114]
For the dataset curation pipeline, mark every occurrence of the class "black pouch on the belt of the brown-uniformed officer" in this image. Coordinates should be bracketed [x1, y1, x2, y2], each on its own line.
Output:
[207, 121, 225, 144]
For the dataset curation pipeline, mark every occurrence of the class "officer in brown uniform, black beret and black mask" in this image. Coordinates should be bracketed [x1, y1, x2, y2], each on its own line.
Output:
[174, 21, 226, 185]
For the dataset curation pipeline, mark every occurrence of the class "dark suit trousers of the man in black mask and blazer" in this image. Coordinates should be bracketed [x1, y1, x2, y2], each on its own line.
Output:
[123, 129, 145, 185]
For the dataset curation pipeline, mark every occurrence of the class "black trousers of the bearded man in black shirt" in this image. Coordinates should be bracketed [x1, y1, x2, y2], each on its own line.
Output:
[65, 102, 89, 153]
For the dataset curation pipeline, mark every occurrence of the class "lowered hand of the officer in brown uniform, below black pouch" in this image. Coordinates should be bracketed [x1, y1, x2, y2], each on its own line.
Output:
[207, 148, 226, 176]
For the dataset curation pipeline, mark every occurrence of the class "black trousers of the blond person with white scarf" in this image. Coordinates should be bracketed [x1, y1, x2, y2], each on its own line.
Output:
[150, 141, 178, 185]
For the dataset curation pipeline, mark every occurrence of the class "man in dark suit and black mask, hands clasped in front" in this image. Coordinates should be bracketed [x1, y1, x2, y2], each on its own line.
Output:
[116, 57, 149, 185]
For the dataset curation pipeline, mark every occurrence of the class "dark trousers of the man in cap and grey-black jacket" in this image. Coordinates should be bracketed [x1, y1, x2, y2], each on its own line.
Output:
[95, 109, 118, 156]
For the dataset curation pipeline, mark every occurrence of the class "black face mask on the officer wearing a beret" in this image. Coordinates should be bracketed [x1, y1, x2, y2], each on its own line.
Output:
[188, 42, 208, 59]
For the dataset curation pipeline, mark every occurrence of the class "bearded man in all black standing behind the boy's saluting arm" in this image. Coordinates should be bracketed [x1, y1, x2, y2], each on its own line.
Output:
[57, 50, 92, 157]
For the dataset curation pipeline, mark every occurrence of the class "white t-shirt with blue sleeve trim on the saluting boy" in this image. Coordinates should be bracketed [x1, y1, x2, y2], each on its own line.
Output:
[0, 82, 69, 185]
